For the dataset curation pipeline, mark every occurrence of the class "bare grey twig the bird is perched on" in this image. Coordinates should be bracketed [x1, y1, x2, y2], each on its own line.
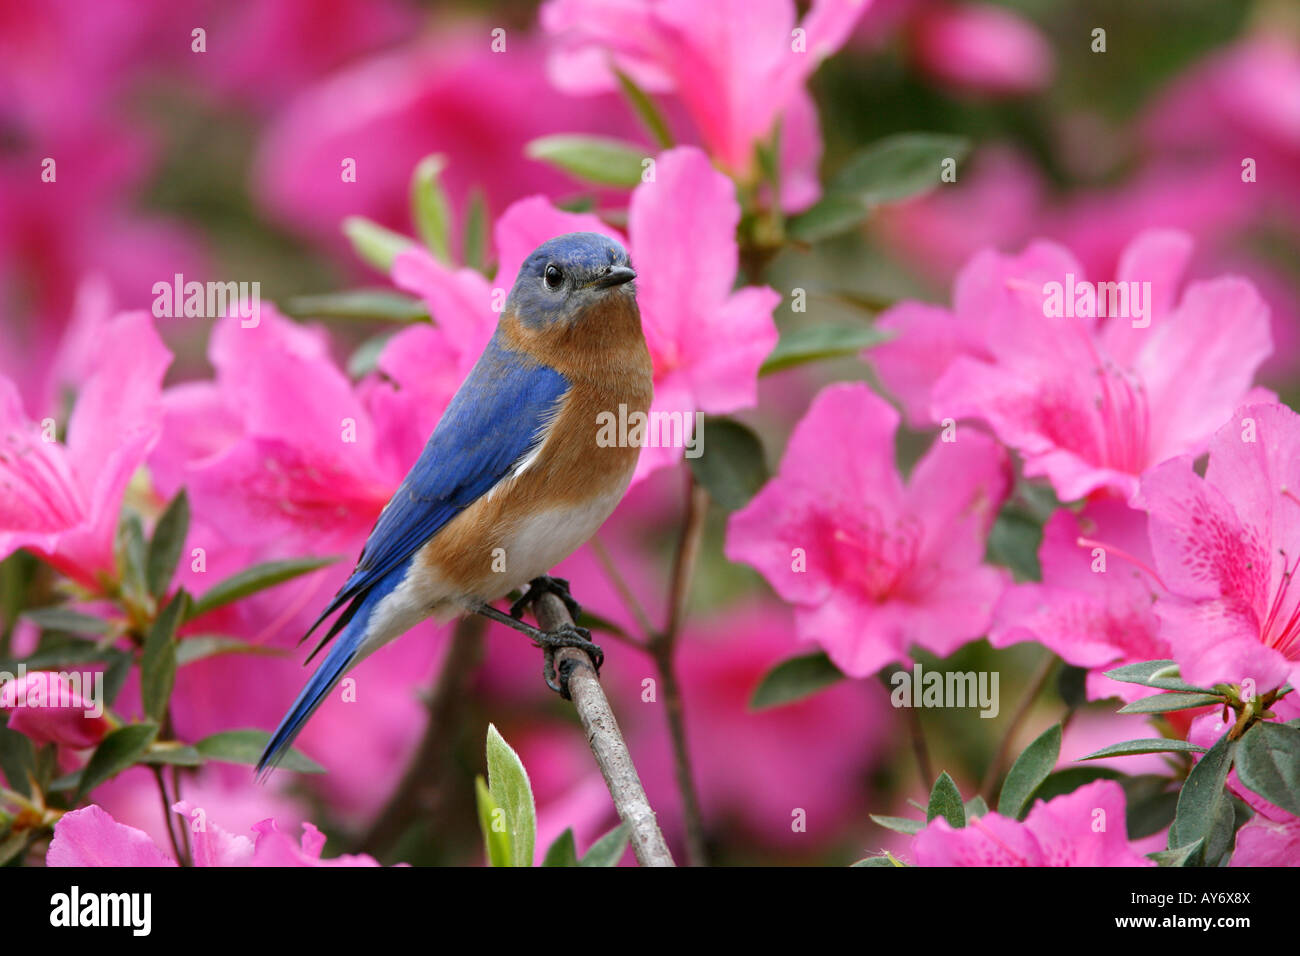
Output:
[533, 593, 673, 866]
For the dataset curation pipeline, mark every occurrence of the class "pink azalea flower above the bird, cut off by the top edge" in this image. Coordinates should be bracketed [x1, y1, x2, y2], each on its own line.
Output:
[541, 0, 870, 211]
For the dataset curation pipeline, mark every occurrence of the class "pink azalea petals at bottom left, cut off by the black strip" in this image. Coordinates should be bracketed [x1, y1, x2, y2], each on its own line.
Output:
[46, 800, 390, 866]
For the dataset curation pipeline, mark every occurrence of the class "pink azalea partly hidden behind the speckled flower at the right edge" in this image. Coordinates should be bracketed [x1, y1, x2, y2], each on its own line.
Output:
[988, 498, 1170, 701]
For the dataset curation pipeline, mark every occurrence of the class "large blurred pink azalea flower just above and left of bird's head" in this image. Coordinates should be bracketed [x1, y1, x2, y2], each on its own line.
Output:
[254, 22, 638, 257]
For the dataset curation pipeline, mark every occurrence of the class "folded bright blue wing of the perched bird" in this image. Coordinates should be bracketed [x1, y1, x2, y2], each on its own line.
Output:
[304, 338, 569, 659]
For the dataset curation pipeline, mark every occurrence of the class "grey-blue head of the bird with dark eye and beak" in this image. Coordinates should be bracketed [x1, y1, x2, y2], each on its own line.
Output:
[506, 233, 637, 328]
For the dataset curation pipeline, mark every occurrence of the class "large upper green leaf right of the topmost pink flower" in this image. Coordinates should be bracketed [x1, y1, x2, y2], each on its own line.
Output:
[829, 133, 970, 207]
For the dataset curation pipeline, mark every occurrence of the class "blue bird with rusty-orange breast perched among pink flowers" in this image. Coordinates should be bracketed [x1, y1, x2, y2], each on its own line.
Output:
[256, 233, 654, 778]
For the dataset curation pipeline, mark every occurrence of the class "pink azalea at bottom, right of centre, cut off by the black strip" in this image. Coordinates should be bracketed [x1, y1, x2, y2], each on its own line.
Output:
[911, 780, 1156, 866]
